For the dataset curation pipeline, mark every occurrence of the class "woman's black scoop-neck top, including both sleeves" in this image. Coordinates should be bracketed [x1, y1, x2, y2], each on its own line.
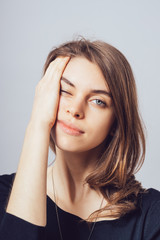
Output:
[0, 173, 160, 240]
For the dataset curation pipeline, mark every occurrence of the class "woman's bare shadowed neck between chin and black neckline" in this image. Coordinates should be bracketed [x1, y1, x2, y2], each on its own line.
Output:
[53, 145, 102, 204]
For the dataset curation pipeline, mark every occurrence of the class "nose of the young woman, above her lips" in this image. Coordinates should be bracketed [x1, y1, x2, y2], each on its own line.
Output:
[67, 99, 84, 119]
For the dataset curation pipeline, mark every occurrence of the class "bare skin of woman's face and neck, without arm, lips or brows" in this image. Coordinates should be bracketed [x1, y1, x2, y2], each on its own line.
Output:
[48, 57, 115, 219]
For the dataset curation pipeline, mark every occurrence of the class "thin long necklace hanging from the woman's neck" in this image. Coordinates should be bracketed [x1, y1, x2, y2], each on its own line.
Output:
[52, 169, 104, 240]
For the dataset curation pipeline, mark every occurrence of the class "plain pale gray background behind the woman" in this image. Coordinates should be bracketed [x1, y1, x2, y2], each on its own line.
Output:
[0, 0, 160, 190]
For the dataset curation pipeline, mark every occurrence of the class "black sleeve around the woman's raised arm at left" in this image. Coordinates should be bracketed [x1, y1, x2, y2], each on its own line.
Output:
[0, 174, 46, 240]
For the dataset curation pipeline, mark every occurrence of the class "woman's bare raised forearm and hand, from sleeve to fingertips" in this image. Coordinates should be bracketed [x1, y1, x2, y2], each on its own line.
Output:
[6, 58, 69, 226]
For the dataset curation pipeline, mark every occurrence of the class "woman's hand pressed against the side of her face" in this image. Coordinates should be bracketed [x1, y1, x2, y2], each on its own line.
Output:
[31, 57, 70, 130]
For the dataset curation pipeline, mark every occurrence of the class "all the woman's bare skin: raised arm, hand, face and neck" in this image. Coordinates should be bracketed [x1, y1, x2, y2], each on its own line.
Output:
[6, 57, 114, 226]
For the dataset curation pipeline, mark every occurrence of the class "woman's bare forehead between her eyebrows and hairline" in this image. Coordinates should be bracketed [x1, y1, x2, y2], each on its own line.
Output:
[62, 57, 109, 90]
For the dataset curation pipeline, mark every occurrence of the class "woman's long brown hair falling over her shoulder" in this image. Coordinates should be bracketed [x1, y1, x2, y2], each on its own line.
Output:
[44, 38, 145, 220]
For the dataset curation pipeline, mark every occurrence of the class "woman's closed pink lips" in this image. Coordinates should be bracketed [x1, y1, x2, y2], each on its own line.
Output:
[57, 120, 84, 136]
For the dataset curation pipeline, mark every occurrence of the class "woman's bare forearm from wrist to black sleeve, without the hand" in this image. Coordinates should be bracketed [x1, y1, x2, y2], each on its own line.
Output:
[6, 122, 50, 226]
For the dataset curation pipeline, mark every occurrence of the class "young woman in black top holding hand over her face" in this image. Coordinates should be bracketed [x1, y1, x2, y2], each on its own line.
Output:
[0, 39, 160, 240]
